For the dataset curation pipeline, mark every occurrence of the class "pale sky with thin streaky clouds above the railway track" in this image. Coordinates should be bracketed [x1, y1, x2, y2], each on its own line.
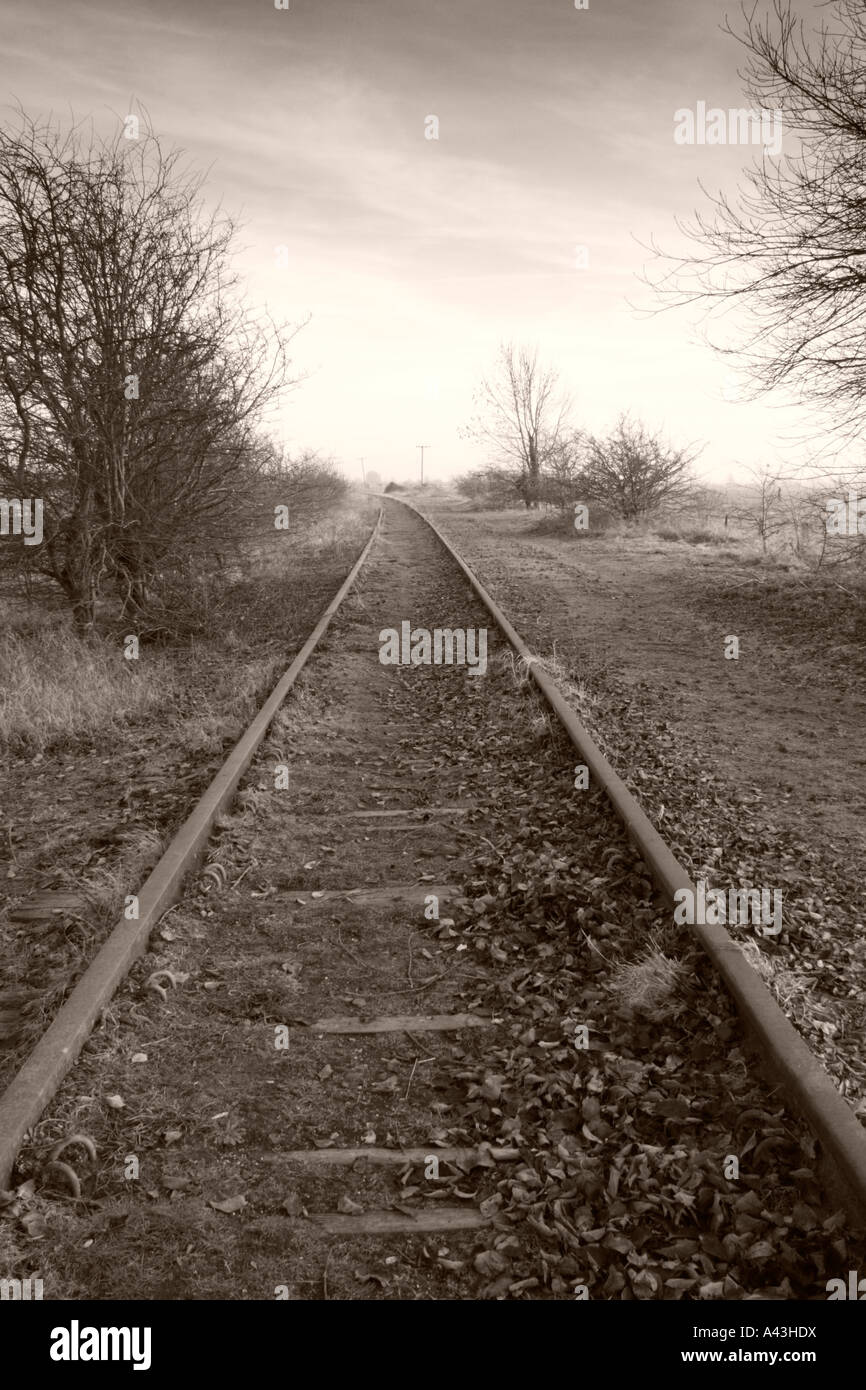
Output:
[0, 0, 828, 481]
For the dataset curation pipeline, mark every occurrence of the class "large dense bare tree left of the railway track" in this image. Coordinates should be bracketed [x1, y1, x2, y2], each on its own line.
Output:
[0, 113, 301, 630]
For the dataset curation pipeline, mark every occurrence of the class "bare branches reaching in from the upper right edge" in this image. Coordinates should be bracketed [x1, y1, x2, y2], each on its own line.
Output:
[649, 0, 866, 438]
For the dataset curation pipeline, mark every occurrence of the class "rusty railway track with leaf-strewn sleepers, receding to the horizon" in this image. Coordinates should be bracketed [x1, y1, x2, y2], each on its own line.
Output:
[0, 503, 866, 1300]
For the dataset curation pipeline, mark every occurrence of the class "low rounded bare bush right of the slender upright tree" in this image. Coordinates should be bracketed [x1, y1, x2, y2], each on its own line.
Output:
[585, 416, 698, 521]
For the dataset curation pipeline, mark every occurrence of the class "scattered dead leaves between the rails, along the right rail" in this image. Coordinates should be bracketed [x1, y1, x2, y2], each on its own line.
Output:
[411, 675, 866, 1300]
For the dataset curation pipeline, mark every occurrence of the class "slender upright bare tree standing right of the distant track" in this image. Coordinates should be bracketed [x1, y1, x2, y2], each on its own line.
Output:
[466, 343, 570, 507]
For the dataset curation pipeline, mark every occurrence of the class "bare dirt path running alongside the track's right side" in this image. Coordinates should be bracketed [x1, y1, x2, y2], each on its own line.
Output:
[416, 499, 866, 862]
